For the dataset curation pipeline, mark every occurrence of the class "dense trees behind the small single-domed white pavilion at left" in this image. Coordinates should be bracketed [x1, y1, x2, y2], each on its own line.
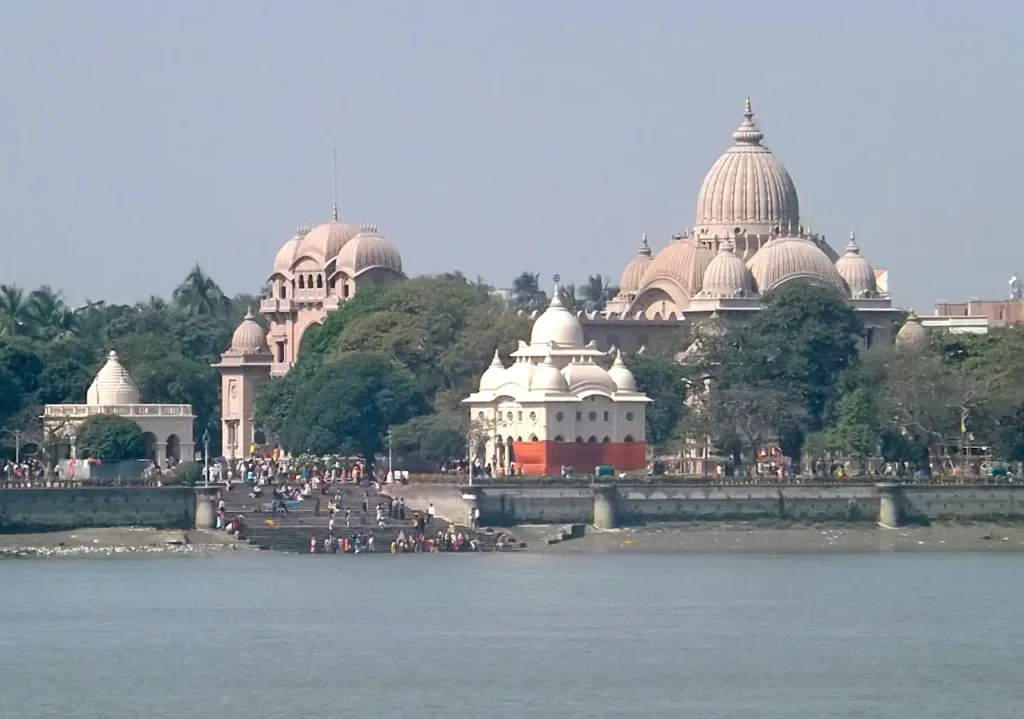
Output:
[0, 267, 258, 456]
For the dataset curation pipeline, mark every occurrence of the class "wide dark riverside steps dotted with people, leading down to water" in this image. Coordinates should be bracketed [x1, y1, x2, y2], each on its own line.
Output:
[221, 482, 498, 554]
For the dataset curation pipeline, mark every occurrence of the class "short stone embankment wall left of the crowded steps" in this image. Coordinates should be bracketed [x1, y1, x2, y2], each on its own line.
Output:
[0, 487, 197, 533]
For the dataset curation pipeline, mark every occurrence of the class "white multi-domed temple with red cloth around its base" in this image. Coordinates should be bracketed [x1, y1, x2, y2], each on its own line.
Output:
[463, 288, 650, 475]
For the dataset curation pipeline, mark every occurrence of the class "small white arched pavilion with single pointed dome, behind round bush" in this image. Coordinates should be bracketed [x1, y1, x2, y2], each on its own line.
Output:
[43, 350, 196, 468]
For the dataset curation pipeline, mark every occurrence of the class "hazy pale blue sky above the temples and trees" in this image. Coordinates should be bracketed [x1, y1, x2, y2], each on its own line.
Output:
[0, 0, 1024, 311]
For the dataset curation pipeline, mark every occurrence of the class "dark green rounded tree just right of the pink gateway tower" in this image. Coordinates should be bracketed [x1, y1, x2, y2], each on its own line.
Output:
[281, 352, 428, 465]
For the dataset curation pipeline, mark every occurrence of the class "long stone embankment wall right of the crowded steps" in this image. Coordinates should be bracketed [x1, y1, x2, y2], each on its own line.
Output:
[392, 483, 1024, 526]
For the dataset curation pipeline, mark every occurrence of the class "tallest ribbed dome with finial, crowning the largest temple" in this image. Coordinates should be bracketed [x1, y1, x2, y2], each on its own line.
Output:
[695, 98, 800, 241]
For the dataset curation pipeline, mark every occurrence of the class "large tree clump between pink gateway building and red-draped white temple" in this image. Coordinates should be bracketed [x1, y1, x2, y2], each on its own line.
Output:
[256, 274, 530, 463]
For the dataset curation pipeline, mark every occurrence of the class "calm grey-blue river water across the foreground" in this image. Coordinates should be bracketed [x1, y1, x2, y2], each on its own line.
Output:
[0, 553, 1024, 719]
